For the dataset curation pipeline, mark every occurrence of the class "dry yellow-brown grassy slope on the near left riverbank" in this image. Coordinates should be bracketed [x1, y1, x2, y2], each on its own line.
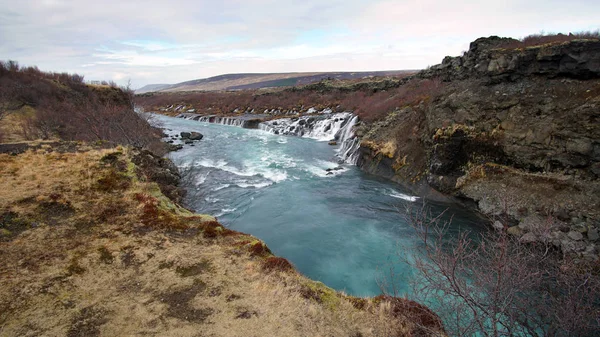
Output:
[0, 143, 440, 336]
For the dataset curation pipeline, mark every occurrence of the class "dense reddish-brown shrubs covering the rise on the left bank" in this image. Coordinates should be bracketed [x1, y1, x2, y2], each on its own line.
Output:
[0, 61, 160, 149]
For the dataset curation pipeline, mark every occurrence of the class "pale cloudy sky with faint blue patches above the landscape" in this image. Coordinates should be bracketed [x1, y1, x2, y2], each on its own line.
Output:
[0, 0, 600, 88]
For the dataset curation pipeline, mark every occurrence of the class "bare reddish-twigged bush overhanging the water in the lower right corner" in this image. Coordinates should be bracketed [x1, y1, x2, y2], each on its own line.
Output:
[398, 205, 600, 336]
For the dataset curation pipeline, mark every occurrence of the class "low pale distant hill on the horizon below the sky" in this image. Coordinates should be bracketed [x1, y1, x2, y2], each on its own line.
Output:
[135, 70, 413, 94]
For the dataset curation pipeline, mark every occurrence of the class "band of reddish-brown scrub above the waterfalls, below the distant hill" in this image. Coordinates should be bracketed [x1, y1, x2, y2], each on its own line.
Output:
[136, 79, 443, 121]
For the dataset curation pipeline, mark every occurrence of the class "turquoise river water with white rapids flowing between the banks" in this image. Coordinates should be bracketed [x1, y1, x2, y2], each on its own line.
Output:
[156, 116, 478, 296]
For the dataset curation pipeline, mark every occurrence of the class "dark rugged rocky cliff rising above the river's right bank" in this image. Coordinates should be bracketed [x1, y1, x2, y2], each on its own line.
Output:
[357, 37, 600, 259]
